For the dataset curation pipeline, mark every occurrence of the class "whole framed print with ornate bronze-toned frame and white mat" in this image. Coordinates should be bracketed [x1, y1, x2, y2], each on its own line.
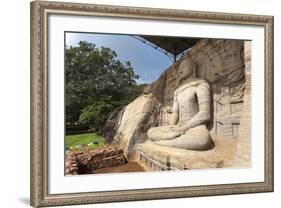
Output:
[31, 1, 273, 207]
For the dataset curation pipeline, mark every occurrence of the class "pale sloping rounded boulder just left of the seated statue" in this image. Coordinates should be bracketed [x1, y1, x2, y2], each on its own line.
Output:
[112, 94, 159, 156]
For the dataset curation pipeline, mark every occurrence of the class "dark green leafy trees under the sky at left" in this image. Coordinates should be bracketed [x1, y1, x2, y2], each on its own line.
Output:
[65, 41, 143, 130]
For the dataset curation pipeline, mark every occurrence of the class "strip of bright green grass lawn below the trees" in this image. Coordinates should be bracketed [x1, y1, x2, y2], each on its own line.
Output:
[65, 133, 105, 148]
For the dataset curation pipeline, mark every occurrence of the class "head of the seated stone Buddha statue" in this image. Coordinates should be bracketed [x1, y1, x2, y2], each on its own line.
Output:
[178, 59, 196, 80]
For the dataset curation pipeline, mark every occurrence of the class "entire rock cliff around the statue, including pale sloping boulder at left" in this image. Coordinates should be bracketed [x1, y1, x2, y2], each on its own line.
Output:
[105, 39, 250, 167]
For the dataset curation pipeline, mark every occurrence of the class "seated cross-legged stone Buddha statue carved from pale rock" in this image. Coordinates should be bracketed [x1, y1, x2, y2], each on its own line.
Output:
[147, 61, 213, 150]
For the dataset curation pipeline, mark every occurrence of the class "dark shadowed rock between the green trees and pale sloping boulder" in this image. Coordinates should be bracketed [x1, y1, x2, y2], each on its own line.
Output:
[102, 107, 125, 144]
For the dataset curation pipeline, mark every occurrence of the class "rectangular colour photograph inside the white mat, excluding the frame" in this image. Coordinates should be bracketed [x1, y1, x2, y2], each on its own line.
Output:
[62, 31, 251, 176]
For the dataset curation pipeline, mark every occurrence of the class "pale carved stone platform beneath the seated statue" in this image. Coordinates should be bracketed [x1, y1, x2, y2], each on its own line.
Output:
[135, 134, 235, 171]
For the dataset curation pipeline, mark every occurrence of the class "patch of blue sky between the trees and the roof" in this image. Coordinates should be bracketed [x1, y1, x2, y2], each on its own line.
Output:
[65, 33, 172, 83]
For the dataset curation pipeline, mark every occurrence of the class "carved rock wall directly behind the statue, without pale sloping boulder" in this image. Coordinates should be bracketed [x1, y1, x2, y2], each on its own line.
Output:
[152, 39, 245, 139]
